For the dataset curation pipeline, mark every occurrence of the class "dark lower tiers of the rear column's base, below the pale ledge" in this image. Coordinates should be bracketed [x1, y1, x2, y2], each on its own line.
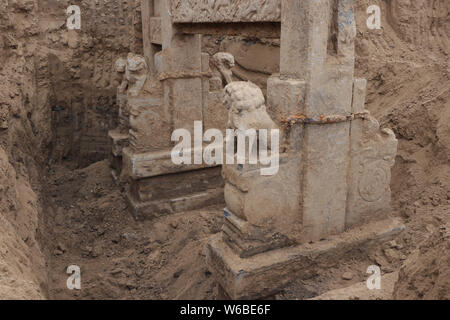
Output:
[127, 167, 225, 220]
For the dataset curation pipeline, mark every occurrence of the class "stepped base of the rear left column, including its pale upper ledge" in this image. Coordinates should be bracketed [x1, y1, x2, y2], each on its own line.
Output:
[122, 148, 225, 220]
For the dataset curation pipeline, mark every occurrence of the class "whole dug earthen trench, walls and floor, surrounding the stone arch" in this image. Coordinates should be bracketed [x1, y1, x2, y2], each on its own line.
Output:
[0, 0, 450, 299]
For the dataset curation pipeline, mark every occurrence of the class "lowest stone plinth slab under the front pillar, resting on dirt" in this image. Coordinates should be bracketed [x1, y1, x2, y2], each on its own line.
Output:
[206, 219, 404, 300]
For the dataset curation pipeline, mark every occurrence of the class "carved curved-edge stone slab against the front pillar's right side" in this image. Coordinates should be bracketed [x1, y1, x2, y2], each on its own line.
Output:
[346, 79, 398, 228]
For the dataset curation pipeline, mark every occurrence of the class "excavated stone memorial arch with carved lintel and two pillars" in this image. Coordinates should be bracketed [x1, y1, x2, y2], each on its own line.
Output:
[109, 0, 404, 299]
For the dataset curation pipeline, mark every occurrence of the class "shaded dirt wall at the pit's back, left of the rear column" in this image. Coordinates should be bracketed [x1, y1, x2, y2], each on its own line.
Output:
[37, 0, 142, 167]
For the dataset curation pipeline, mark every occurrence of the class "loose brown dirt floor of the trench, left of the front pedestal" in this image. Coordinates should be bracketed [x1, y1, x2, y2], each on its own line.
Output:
[41, 161, 222, 299]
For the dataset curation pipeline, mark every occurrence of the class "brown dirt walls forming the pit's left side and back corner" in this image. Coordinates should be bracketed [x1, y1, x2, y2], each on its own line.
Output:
[0, 0, 142, 298]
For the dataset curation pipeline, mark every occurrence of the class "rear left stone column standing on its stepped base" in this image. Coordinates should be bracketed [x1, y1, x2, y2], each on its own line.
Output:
[124, 0, 223, 219]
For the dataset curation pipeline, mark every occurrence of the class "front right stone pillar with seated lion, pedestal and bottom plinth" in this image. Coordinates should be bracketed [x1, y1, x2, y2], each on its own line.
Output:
[207, 0, 403, 299]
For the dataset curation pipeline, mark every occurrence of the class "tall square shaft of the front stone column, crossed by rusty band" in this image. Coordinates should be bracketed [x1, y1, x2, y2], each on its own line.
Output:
[272, 0, 356, 242]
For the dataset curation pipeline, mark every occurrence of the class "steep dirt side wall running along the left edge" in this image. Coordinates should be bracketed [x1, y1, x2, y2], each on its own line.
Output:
[0, 0, 46, 299]
